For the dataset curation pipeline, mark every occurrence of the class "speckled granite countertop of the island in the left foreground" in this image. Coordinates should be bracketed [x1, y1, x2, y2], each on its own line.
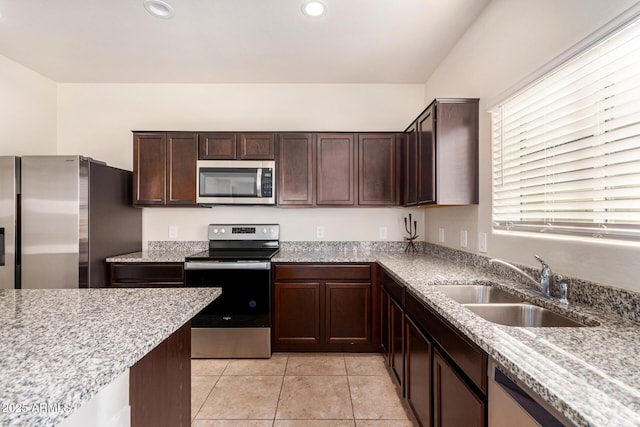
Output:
[0, 288, 220, 427]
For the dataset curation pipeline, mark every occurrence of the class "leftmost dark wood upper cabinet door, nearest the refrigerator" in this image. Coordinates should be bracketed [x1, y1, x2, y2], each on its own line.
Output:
[133, 133, 167, 206]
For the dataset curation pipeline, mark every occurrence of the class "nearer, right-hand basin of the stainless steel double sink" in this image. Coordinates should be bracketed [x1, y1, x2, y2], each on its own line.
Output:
[464, 303, 585, 327]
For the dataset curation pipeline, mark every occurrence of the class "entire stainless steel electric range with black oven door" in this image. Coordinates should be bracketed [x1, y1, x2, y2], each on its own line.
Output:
[184, 224, 280, 358]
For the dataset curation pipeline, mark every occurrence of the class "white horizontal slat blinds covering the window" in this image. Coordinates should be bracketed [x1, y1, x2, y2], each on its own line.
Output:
[491, 16, 640, 240]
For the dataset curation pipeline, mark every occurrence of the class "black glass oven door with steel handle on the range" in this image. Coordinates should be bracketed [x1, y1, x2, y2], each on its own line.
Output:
[185, 261, 271, 328]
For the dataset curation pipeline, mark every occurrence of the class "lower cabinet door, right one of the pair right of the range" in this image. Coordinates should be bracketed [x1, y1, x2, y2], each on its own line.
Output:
[325, 282, 371, 344]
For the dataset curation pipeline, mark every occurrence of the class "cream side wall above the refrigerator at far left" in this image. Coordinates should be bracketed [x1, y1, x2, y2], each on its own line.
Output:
[0, 55, 57, 156]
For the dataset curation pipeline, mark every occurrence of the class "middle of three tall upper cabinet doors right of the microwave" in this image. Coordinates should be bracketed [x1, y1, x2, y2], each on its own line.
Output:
[316, 134, 355, 206]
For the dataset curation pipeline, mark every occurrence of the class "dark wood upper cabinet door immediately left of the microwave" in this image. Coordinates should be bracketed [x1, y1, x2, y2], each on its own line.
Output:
[166, 133, 198, 206]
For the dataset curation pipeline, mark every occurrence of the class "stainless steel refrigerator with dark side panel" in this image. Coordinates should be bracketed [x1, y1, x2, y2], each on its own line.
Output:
[0, 156, 142, 289]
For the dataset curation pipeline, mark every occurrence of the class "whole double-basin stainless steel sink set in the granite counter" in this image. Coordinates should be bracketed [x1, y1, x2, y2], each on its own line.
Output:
[436, 285, 585, 327]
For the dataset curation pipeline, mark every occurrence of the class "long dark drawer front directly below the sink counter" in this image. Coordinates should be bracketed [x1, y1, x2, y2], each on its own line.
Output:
[405, 292, 487, 394]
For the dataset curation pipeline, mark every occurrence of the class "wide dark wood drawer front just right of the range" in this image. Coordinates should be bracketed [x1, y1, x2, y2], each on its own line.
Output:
[274, 264, 371, 281]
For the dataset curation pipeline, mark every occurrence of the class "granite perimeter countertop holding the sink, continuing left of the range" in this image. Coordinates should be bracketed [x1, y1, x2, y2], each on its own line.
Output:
[105, 246, 640, 426]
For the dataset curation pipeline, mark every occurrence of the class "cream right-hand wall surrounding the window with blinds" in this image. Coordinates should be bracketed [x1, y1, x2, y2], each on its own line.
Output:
[425, 0, 640, 291]
